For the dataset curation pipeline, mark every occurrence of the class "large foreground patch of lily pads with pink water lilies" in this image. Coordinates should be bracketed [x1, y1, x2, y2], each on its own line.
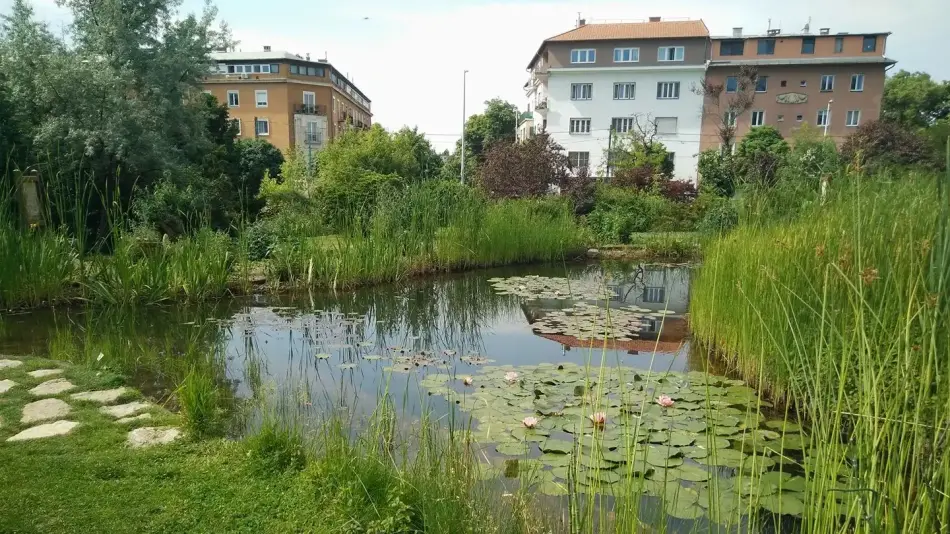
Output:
[420, 363, 824, 522]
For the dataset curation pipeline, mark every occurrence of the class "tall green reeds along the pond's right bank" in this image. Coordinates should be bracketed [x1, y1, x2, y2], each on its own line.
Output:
[691, 170, 950, 533]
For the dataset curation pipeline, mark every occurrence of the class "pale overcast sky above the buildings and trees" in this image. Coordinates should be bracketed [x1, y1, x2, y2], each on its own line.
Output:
[0, 0, 950, 150]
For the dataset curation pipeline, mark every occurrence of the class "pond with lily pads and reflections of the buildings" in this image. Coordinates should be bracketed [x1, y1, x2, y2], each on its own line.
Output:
[0, 264, 804, 531]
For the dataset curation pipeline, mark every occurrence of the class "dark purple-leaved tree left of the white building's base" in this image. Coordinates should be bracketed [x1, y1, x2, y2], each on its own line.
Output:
[478, 134, 577, 198]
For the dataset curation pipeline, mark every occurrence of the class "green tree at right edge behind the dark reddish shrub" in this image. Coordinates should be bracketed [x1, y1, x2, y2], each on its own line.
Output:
[881, 70, 950, 128]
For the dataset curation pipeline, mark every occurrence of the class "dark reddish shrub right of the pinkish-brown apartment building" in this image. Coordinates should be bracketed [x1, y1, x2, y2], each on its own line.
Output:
[841, 121, 934, 173]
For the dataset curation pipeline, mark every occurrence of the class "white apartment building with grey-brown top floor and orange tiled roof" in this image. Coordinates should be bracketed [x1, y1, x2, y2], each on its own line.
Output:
[525, 17, 710, 181]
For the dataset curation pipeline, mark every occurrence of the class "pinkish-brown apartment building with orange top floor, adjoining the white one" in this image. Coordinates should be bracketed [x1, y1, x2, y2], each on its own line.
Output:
[700, 26, 896, 150]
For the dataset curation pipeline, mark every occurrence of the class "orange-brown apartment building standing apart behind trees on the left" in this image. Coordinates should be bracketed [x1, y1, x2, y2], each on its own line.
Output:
[204, 47, 373, 152]
